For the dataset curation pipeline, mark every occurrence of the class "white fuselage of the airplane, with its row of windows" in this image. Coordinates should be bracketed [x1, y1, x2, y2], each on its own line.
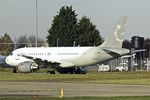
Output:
[6, 47, 118, 67]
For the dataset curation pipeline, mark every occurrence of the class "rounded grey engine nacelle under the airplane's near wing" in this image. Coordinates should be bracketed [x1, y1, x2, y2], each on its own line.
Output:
[18, 61, 39, 73]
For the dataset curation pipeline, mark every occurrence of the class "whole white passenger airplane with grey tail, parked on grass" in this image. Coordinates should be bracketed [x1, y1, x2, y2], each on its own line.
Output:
[5, 16, 130, 74]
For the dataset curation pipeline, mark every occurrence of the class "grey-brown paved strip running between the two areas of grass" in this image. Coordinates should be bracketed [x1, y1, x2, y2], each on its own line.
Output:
[0, 82, 150, 97]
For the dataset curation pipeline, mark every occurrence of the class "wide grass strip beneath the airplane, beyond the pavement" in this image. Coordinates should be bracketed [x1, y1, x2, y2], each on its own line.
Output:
[0, 68, 150, 85]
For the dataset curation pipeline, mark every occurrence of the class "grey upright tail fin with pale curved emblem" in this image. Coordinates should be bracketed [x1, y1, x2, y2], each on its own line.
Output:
[100, 16, 127, 48]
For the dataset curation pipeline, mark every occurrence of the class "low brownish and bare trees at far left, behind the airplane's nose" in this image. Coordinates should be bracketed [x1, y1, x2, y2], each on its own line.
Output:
[0, 33, 45, 56]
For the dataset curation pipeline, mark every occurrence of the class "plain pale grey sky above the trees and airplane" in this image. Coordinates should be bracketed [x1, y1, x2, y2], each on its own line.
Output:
[0, 0, 150, 40]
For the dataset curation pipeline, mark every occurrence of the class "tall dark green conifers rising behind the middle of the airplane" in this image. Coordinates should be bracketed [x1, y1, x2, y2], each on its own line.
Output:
[46, 6, 104, 47]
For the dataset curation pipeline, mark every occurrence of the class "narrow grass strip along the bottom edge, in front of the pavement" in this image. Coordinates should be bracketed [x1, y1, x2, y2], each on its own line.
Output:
[0, 96, 150, 100]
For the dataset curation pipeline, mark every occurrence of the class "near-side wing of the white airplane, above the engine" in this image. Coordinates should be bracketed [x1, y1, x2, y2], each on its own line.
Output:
[22, 55, 74, 67]
